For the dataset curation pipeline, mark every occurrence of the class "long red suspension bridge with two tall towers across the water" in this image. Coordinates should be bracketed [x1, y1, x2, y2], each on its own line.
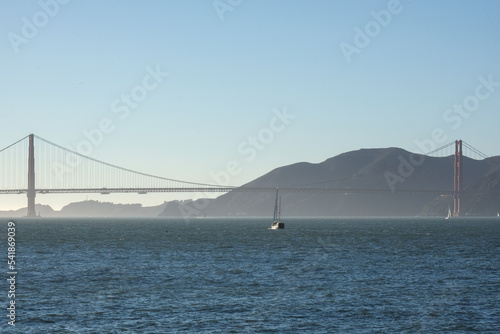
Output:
[0, 134, 487, 217]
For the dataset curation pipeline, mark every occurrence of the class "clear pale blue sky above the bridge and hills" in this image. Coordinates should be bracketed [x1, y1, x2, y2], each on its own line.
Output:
[0, 0, 500, 206]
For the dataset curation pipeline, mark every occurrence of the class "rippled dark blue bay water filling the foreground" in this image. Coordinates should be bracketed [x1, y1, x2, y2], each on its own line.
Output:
[1, 218, 500, 333]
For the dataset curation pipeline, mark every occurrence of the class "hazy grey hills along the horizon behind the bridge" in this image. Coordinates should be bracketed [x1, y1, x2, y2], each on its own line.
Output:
[0, 148, 500, 218]
